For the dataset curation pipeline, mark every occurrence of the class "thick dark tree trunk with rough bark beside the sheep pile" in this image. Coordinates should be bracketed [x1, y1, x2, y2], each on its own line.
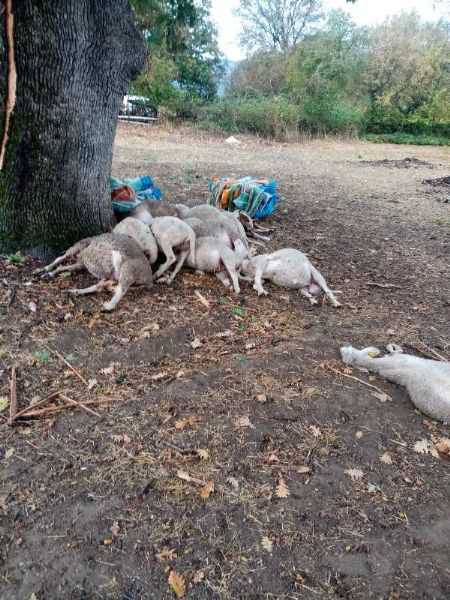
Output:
[0, 0, 145, 258]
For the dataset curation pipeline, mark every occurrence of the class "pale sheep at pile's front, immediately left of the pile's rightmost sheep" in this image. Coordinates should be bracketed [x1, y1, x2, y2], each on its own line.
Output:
[186, 237, 248, 294]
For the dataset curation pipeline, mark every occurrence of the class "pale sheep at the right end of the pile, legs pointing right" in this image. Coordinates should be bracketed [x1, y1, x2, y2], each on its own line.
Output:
[241, 248, 341, 308]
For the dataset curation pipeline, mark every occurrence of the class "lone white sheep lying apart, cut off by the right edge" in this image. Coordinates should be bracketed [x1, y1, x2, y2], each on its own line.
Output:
[341, 345, 450, 423]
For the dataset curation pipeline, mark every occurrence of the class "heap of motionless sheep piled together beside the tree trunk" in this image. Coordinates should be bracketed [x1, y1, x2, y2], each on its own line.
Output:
[37, 200, 340, 311]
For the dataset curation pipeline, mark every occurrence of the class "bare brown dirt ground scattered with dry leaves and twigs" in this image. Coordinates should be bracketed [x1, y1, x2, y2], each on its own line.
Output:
[0, 126, 450, 600]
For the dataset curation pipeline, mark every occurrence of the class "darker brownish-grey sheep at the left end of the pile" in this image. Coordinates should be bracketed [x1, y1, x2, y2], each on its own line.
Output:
[36, 233, 152, 311]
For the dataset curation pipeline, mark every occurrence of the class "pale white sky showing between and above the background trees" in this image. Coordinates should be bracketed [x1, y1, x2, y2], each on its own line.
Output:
[212, 0, 450, 60]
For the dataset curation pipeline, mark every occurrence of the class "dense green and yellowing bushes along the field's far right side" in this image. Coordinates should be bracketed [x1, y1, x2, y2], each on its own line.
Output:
[209, 11, 450, 139]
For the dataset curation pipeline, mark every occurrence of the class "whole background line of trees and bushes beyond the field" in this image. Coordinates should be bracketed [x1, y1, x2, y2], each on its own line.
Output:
[134, 0, 450, 142]
